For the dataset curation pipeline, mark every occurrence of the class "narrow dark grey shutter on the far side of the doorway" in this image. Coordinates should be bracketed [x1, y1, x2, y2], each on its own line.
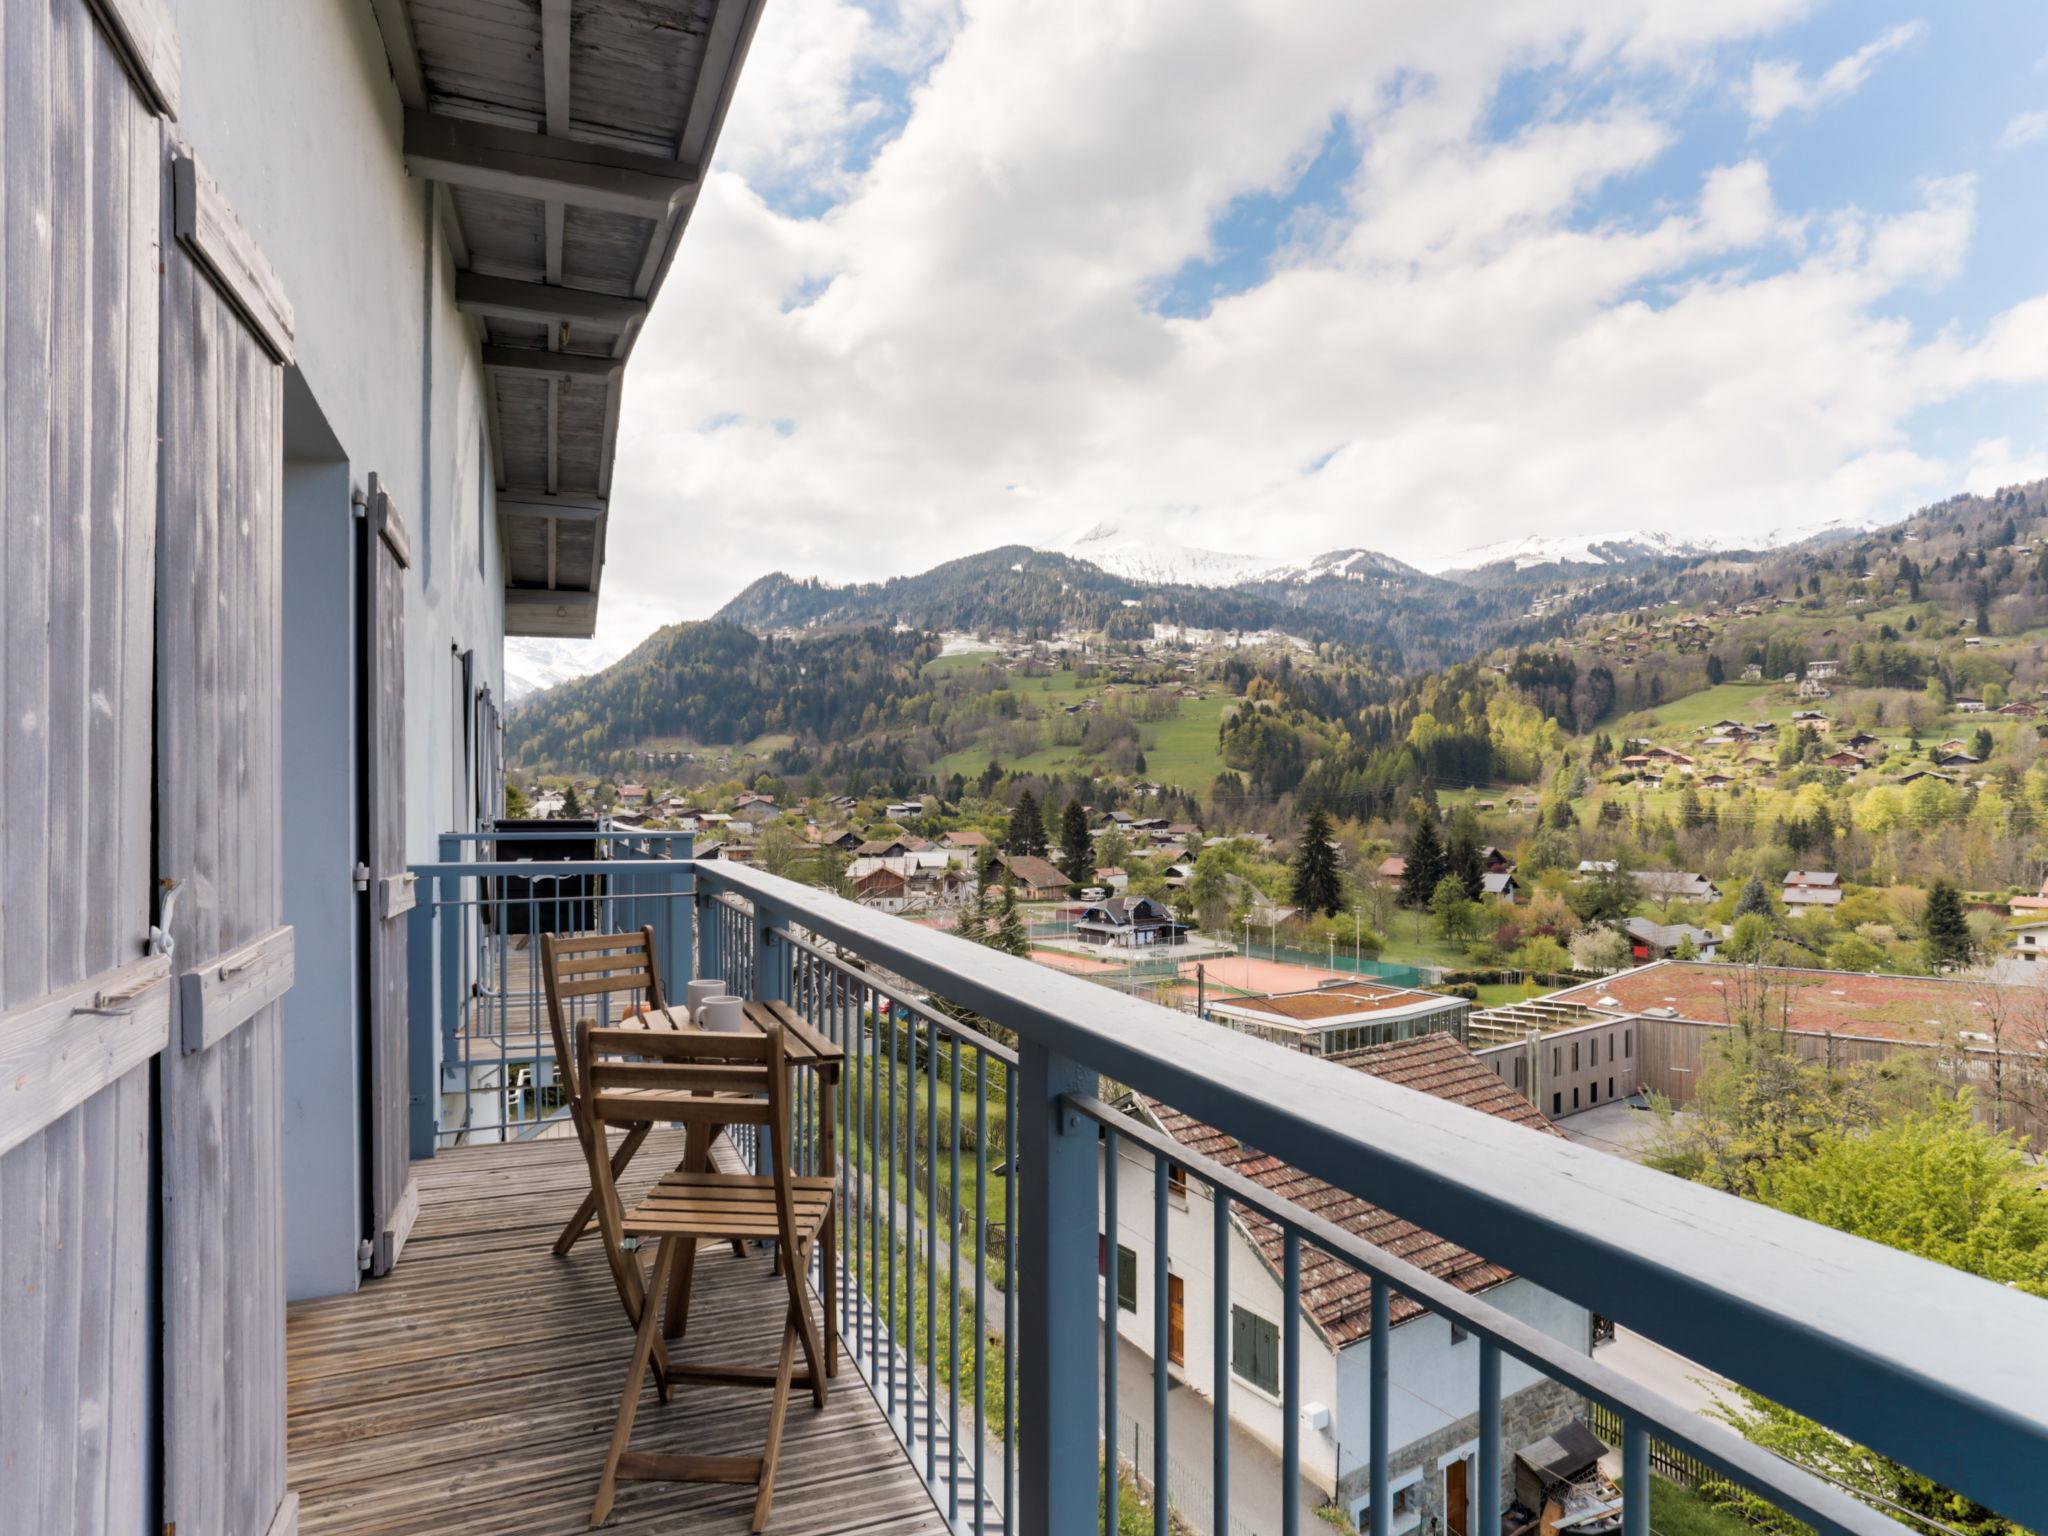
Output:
[362, 487, 420, 1276]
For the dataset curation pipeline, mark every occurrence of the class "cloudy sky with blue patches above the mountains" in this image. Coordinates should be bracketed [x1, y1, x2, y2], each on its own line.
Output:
[540, 0, 2048, 653]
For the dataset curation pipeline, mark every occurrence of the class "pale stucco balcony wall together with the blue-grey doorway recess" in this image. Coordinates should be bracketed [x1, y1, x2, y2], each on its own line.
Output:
[170, 0, 520, 1296]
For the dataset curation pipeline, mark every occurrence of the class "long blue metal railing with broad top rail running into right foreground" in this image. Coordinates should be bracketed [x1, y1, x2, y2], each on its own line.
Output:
[698, 864, 2048, 1536]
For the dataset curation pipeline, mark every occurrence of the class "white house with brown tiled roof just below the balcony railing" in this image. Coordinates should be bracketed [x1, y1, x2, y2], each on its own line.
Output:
[1098, 1034, 1591, 1536]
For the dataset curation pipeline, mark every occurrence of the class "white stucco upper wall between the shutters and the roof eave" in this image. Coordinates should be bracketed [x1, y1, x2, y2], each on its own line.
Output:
[172, 0, 504, 858]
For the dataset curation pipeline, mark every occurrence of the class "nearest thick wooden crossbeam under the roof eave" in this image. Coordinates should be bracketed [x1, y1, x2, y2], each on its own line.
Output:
[406, 111, 698, 219]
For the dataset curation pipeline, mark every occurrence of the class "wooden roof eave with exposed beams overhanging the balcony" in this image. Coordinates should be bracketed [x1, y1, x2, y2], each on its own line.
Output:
[371, 0, 762, 637]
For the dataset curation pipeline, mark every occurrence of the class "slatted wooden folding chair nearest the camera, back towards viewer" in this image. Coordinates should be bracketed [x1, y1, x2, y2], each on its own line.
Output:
[578, 1020, 834, 1530]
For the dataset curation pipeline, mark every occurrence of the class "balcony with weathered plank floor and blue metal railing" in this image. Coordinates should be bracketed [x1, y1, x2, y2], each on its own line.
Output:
[291, 840, 2048, 1536]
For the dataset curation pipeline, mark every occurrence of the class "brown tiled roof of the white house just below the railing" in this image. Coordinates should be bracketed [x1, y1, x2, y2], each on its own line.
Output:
[1139, 1034, 1561, 1348]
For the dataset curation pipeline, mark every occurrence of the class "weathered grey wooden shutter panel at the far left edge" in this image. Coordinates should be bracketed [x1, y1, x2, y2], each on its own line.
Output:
[0, 0, 176, 1536]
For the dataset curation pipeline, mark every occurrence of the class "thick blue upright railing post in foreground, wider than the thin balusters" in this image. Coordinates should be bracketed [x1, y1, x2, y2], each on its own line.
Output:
[1010, 1038, 1114, 1536]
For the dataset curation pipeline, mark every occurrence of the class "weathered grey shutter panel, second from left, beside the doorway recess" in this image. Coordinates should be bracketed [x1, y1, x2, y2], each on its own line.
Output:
[156, 145, 293, 1536]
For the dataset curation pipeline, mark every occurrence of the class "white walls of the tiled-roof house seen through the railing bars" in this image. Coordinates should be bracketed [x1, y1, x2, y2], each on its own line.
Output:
[1104, 1143, 1591, 1489]
